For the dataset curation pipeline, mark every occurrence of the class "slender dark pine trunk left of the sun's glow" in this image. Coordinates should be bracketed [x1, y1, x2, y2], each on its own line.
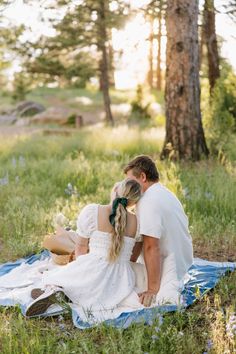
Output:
[98, 0, 114, 125]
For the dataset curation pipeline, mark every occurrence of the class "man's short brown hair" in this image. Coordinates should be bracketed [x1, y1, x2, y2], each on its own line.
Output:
[124, 155, 159, 182]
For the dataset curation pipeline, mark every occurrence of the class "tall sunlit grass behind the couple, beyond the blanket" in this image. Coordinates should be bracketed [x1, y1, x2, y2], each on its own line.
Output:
[0, 127, 236, 260]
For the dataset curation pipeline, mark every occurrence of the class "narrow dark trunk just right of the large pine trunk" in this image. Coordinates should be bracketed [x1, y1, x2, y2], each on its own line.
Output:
[203, 0, 220, 95]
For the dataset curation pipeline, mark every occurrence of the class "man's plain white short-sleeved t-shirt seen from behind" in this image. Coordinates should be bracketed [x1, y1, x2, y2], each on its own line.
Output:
[137, 182, 193, 280]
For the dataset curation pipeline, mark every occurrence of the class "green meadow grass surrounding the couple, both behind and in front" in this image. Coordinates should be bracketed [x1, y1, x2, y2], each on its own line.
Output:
[0, 126, 236, 354]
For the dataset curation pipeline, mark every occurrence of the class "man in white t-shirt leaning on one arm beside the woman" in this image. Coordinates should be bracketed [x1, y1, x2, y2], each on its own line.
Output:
[124, 155, 193, 306]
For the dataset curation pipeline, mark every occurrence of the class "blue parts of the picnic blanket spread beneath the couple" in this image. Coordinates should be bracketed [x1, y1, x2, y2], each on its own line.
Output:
[0, 250, 236, 329]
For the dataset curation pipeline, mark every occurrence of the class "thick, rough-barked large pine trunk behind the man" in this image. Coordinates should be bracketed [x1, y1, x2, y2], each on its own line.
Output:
[161, 0, 209, 161]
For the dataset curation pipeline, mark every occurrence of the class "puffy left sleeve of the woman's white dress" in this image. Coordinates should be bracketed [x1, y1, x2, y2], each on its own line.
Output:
[76, 204, 97, 238]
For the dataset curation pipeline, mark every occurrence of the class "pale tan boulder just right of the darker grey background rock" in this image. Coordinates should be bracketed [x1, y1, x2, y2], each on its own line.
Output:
[31, 107, 70, 124]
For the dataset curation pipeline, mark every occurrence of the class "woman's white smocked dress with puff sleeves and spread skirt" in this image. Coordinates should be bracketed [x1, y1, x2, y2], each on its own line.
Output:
[42, 204, 143, 321]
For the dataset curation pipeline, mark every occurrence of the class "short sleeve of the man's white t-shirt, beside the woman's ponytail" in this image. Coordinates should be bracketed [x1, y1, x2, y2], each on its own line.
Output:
[137, 201, 163, 238]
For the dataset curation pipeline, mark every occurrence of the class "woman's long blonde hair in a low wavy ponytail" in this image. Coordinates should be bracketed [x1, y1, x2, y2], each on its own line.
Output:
[109, 179, 141, 262]
